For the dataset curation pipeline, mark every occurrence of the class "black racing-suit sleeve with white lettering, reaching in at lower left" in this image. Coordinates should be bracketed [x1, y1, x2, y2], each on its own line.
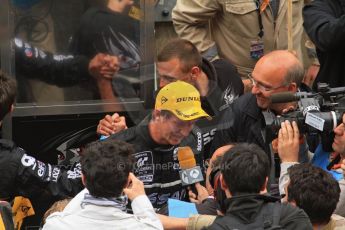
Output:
[0, 139, 84, 201]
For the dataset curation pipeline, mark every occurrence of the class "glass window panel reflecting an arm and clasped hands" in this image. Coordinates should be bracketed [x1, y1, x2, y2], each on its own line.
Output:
[0, 0, 154, 115]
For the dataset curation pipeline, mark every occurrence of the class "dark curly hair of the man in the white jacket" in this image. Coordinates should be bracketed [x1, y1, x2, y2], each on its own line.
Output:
[81, 139, 134, 198]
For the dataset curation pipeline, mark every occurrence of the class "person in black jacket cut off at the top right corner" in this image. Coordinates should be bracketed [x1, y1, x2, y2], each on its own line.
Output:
[303, 0, 345, 90]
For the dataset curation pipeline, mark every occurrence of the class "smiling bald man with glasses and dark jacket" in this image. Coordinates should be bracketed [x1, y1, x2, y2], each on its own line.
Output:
[212, 50, 304, 195]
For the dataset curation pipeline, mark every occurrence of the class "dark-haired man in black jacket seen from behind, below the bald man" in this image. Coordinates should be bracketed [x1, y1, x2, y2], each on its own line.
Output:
[207, 143, 313, 230]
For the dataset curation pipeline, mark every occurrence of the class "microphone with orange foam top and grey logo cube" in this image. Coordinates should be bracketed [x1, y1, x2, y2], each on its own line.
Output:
[177, 146, 204, 186]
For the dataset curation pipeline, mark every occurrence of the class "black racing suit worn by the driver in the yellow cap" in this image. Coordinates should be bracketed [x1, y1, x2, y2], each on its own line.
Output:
[106, 119, 203, 209]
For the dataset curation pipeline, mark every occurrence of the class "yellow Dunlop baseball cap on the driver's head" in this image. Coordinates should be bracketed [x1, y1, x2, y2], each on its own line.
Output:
[155, 81, 211, 121]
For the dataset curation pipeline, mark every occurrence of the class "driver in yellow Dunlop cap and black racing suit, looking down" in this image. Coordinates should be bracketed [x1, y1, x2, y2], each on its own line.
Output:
[105, 81, 210, 209]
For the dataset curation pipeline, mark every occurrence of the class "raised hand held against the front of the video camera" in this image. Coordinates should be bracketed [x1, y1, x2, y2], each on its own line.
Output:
[278, 121, 300, 162]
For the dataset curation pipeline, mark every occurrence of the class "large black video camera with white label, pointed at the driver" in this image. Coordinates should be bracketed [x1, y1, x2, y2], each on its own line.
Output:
[263, 83, 345, 149]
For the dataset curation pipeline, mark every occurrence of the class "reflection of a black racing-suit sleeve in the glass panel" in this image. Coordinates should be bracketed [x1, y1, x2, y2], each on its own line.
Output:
[13, 38, 90, 86]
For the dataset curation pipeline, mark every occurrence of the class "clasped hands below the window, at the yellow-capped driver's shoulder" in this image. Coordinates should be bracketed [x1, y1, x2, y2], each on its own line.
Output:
[97, 113, 127, 136]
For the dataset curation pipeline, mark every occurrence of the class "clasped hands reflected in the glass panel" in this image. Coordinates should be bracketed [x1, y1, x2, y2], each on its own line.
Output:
[89, 53, 120, 80]
